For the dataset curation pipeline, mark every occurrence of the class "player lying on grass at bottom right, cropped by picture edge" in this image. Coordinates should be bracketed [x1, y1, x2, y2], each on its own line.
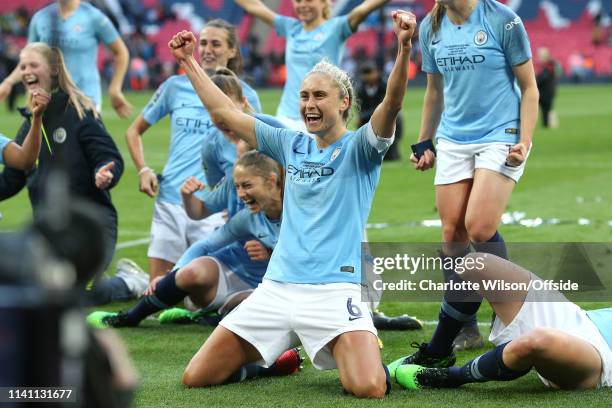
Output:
[389, 253, 612, 389]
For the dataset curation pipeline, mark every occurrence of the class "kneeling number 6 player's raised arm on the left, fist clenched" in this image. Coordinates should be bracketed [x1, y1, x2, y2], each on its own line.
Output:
[168, 30, 257, 147]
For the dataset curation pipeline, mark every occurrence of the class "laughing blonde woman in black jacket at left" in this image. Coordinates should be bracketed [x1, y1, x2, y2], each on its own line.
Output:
[0, 43, 123, 278]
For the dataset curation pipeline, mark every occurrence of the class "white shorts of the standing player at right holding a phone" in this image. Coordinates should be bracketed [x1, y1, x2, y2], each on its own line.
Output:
[434, 138, 531, 186]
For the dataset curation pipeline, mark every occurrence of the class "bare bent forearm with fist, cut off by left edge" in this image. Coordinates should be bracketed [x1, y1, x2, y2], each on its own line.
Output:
[4, 89, 51, 170]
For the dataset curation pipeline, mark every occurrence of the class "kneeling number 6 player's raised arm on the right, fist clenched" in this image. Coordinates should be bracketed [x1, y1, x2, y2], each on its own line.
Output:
[370, 10, 416, 138]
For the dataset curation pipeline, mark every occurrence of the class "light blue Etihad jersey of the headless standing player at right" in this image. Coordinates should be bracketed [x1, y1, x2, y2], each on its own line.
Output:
[419, 0, 531, 144]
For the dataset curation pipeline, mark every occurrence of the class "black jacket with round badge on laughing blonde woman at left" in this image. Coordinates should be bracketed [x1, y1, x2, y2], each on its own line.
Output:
[0, 91, 123, 217]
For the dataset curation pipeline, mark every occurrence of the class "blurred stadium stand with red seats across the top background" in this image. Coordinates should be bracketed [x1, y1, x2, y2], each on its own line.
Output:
[0, 0, 612, 85]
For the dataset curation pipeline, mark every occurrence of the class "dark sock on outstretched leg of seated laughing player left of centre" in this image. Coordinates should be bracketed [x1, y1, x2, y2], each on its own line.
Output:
[127, 271, 187, 326]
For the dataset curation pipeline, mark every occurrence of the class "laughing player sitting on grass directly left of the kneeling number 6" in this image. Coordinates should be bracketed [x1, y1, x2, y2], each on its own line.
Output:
[88, 151, 283, 328]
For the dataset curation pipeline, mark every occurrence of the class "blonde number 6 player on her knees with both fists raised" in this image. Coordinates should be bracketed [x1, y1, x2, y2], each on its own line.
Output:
[169, 11, 416, 398]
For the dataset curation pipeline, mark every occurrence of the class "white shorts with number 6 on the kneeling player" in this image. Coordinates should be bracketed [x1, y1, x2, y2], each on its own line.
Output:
[220, 279, 377, 370]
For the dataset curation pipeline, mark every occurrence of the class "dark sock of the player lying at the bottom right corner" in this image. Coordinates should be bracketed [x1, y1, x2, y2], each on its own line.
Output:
[448, 342, 531, 385]
